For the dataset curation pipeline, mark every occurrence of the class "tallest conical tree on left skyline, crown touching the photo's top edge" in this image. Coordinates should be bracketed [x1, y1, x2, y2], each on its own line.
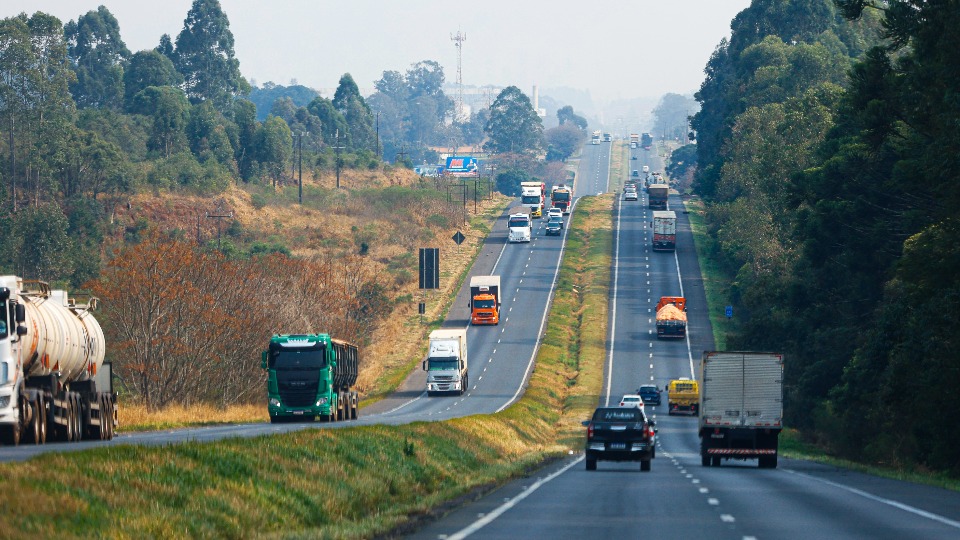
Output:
[174, 0, 250, 111]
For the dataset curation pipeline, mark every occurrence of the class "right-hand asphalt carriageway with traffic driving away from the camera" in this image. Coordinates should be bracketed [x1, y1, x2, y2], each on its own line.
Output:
[410, 144, 960, 540]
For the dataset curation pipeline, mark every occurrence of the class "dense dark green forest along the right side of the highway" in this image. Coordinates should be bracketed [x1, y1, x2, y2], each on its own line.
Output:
[693, 0, 960, 474]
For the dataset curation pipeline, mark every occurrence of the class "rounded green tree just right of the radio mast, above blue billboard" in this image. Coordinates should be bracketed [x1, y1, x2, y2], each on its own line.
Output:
[484, 86, 543, 154]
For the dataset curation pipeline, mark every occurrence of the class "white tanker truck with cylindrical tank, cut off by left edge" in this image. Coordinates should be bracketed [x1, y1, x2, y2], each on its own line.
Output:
[0, 276, 117, 445]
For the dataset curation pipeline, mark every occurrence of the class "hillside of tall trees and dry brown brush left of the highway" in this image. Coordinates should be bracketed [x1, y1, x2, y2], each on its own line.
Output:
[0, 0, 586, 407]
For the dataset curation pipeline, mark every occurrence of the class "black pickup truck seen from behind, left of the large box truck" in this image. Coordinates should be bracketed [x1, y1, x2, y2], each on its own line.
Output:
[583, 407, 656, 472]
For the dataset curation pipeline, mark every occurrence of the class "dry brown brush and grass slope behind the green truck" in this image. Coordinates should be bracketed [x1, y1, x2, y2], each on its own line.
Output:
[97, 169, 507, 416]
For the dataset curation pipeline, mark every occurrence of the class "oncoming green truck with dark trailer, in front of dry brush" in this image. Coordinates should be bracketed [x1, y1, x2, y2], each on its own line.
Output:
[260, 334, 360, 423]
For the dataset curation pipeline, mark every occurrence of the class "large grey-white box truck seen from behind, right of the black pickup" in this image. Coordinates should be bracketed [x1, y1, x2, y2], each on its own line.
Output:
[699, 351, 783, 469]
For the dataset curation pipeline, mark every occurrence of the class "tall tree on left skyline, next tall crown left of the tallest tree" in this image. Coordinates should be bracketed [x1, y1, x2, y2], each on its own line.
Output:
[64, 6, 130, 110]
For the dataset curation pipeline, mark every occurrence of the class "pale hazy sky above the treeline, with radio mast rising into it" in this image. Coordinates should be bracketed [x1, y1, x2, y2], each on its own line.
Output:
[9, 0, 750, 103]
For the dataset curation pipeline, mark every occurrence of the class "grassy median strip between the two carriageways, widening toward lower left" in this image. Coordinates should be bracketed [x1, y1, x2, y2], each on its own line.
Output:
[0, 197, 612, 538]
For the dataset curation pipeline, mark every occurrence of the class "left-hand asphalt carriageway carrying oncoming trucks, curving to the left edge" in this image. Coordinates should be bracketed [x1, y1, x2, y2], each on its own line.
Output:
[0, 139, 611, 461]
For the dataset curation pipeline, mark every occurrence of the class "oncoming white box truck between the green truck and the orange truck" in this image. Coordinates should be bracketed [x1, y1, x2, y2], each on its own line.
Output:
[422, 328, 470, 396]
